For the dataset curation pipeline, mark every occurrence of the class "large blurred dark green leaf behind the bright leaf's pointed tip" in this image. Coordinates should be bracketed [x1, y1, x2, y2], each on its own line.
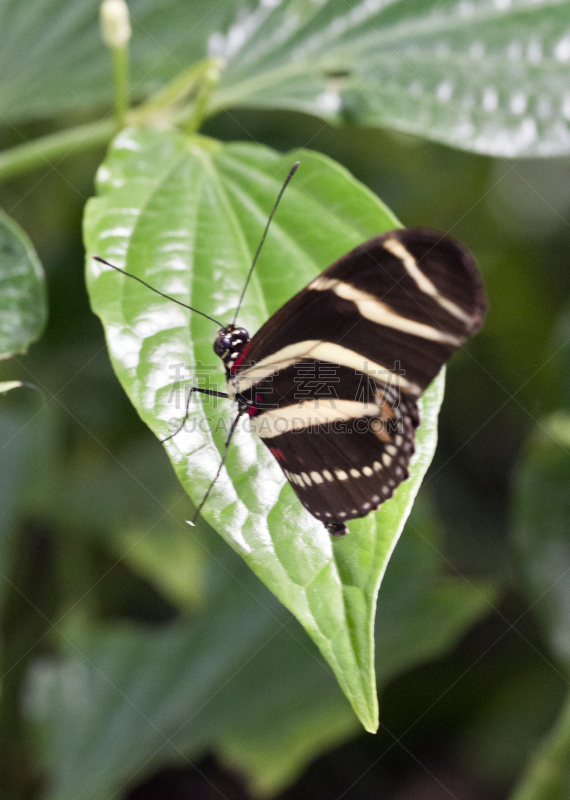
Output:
[30, 496, 492, 800]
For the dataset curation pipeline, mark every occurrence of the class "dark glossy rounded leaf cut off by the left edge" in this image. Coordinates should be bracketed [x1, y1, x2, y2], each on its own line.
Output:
[0, 210, 47, 358]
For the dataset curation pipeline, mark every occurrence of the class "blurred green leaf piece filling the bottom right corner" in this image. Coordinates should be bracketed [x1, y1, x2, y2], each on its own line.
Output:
[510, 692, 570, 800]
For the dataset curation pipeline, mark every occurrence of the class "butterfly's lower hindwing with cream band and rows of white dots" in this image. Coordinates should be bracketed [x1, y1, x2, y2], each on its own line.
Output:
[251, 370, 419, 532]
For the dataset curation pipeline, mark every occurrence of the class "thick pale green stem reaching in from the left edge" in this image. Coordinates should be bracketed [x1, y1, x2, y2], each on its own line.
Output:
[0, 118, 117, 180]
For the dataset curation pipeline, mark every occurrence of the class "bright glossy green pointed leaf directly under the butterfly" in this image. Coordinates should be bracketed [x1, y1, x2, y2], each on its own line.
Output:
[85, 130, 443, 730]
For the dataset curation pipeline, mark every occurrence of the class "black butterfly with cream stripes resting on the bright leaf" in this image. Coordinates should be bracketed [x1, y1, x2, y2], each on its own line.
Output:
[96, 164, 487, 536]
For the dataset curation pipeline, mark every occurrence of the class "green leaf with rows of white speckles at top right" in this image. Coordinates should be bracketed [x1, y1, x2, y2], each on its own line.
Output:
[210, 0, 570, 156]
